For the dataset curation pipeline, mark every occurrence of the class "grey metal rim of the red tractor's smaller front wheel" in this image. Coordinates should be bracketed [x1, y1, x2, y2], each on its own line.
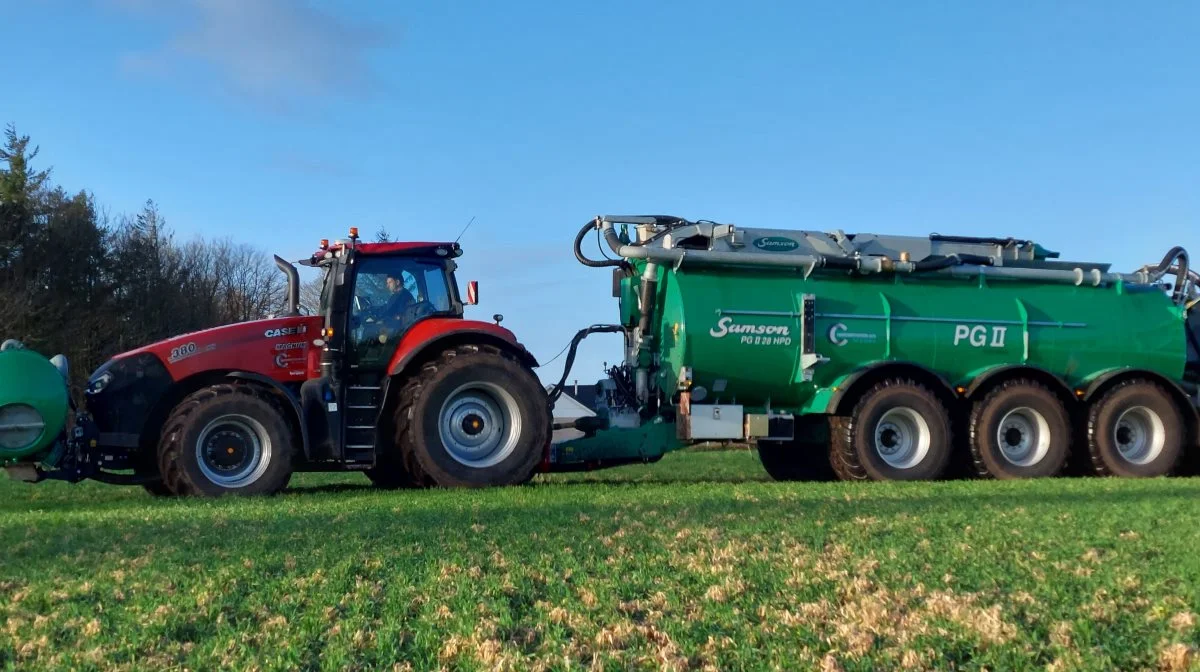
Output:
[196, 415, 272, 487]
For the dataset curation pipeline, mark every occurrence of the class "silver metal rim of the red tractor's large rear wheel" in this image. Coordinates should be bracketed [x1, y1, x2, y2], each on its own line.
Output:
[438, 383, 521, 469]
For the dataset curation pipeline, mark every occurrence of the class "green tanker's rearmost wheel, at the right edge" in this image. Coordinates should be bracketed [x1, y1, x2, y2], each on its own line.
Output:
[1087, 380, 1183, 478]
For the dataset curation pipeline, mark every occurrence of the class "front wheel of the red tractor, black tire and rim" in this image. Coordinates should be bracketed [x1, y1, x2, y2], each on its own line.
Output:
[158, 384, 295, 497]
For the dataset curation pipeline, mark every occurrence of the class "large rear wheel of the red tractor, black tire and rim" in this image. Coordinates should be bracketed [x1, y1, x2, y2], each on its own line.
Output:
[395, 346, 551, 487]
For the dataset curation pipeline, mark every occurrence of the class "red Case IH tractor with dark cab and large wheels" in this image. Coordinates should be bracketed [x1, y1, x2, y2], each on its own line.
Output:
[77, 229, 551, 496]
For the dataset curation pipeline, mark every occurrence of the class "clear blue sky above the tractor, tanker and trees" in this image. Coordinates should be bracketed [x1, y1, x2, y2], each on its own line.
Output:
[0, 0, 1200, 382]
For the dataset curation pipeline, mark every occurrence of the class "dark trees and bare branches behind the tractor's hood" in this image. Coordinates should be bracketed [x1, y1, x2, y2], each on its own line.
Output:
[0, 125, 287, 390]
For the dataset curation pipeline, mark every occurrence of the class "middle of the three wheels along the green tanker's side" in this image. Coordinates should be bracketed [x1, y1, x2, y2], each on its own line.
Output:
[968, 379, 1072, 479]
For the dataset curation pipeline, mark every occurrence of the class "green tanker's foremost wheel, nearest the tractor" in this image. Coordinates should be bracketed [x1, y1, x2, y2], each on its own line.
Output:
[830, 379, 953, 481]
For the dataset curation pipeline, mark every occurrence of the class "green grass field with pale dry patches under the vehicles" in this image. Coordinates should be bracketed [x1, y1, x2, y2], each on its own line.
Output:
[0, 451, 1200, 671]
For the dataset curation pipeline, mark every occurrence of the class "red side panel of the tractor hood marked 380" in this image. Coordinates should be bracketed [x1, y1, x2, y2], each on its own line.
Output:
[114, 316, 324, 383]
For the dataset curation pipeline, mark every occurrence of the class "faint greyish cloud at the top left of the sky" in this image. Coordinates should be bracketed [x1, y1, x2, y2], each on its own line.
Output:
[108, 0, 388, 107]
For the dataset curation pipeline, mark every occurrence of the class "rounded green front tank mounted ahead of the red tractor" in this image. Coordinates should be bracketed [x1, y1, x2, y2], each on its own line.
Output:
[0, 346, 70, 463]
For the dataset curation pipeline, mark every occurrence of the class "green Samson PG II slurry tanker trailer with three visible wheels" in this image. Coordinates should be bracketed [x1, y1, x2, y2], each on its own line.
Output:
[551, 216, 1200, 480]
